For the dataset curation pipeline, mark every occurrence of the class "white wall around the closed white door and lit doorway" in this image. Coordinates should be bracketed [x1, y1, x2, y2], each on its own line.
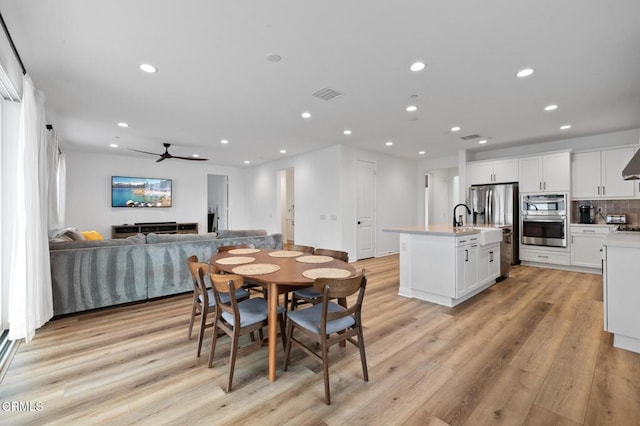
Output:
[246, 145, 417, 259]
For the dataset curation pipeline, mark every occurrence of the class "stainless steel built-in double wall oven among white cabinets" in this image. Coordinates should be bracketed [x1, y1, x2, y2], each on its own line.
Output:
[520, 194, 568, 247]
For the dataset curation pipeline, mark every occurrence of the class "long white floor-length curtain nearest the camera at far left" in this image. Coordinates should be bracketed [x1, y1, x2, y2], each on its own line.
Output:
[9, 75, 53, 342]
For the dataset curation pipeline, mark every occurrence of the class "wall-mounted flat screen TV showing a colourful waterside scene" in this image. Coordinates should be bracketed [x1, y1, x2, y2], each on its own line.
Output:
[111, 176, 171, 207]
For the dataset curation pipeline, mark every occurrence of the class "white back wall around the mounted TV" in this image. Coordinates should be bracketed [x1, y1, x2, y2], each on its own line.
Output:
[65, 150, 251, 238]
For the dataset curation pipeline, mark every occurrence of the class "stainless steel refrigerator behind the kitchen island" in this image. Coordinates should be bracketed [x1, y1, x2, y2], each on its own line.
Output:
[469, 183, 520, 276]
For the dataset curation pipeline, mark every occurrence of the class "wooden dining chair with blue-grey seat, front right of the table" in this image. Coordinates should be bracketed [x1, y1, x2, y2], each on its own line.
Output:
[284, 270, 369, 405]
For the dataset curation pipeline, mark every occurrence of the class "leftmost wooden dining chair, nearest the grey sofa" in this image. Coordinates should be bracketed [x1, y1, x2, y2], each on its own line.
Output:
[187, 256, 249, 356]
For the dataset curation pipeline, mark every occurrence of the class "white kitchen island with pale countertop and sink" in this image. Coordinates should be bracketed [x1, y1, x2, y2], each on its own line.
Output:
[383, 225, 502, 307]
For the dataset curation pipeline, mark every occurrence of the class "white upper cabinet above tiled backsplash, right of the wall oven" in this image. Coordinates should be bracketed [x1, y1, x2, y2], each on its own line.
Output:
[571, 147, 635, 199]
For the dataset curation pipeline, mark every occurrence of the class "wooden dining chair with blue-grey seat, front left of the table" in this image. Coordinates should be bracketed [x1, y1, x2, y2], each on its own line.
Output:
[206, 269, 286, 392]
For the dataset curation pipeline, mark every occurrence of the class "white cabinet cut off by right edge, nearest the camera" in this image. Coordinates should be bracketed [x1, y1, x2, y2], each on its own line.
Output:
[603, 232, 640, 353]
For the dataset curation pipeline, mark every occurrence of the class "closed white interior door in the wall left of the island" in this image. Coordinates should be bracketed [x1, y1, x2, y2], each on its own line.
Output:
[356, 161, 376, 260]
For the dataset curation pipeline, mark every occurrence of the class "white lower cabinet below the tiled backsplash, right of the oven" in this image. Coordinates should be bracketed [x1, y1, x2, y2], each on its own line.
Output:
[571, 225, 612, 269]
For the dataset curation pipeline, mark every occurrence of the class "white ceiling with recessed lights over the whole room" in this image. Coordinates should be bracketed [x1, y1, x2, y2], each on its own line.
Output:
[0, 0, 640, 166]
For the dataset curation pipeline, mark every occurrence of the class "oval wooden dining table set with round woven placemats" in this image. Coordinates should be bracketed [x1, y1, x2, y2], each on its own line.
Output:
[211, 248, 355, 382]
